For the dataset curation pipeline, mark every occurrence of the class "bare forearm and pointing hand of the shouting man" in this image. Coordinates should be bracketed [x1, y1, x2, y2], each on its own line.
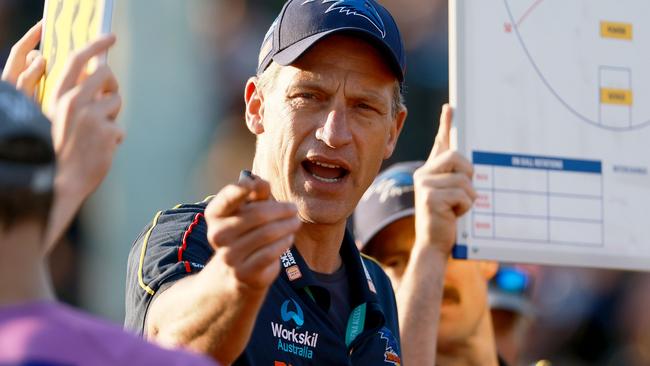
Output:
[145, 178, 301, 364]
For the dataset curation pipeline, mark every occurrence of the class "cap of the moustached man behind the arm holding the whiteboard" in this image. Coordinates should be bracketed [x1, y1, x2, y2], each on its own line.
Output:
[353, 161, 424, 250]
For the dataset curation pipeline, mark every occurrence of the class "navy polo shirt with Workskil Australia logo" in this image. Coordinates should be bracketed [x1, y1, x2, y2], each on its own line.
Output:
[125, 202, 401, 366]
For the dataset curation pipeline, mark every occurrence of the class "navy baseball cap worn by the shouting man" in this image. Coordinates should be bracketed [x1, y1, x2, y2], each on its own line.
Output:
[257, 0, 406, 82]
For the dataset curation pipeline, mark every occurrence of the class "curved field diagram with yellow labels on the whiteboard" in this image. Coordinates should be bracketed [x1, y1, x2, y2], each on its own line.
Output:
[503, 0, 650, 130]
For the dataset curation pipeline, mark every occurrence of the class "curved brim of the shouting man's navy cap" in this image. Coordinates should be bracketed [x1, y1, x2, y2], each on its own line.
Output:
[272, 27, 404, 82]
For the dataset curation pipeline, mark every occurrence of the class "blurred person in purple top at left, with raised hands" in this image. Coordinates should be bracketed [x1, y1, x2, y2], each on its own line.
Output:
[0, 24, 213, 365]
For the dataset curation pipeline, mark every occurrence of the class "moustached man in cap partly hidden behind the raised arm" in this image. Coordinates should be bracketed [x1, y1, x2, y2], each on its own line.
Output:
[353, 161, 505, 366]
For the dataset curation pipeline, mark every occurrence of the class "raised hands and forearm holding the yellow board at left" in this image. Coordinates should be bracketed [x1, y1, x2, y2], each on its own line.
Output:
[2, 22, 124, 252]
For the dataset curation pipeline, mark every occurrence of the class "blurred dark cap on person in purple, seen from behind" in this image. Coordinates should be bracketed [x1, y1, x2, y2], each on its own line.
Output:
[0, 82, 56, 193]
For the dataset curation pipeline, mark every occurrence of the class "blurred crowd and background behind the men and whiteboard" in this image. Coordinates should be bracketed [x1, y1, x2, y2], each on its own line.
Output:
[0, 0, 650, 365]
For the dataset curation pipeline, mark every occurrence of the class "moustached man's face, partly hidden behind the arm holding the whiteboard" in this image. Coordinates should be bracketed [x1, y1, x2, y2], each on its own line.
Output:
[367, 216, 496, 344]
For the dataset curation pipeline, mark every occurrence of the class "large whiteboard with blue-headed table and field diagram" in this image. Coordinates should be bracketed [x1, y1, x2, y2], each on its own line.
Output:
[450, 0, 650, 270]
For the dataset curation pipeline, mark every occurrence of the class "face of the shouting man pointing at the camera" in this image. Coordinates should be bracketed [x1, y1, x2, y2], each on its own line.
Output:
[247, 35, 406, 224]
